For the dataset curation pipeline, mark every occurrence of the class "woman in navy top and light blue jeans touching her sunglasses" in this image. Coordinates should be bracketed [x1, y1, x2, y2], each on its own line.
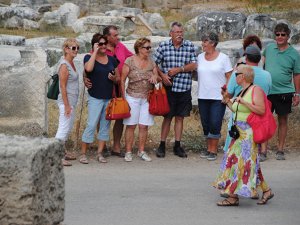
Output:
[79, 33, 120, 164]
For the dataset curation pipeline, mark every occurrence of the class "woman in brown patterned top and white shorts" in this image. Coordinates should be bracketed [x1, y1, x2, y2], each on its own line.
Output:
[121, 38, 158, 162]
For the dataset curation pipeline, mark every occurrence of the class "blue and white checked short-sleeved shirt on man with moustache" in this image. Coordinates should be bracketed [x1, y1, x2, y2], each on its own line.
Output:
[154, 39, 197, 92]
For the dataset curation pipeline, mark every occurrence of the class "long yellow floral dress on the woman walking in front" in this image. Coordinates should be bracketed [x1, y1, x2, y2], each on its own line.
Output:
[213, 89, 269, 198]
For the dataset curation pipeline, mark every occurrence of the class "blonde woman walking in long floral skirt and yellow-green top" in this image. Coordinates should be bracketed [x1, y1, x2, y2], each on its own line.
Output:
[214, 65, 274, 206]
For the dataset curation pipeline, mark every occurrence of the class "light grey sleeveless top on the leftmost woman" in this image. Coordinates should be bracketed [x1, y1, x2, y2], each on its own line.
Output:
[57, 58, 79, 106]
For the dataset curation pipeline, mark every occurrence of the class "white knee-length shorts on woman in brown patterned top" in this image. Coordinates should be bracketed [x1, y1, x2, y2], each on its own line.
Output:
[123, 95, 154, 126]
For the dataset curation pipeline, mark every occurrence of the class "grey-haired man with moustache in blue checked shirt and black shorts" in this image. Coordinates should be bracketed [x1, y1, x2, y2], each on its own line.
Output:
[154, 22, 197, 158]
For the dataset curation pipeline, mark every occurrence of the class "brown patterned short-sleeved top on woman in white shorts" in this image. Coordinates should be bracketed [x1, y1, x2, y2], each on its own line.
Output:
[125, 56, 156, 98]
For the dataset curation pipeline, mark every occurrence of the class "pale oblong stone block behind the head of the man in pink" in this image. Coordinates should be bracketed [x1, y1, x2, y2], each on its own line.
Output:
[73, 16, 135, 36]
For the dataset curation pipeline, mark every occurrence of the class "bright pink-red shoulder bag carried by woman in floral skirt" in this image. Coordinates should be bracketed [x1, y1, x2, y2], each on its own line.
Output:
[247, 86, 277, 143]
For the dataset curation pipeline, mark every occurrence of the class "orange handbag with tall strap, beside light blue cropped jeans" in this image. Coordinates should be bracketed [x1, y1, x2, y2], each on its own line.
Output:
[105, 85, 131, 120]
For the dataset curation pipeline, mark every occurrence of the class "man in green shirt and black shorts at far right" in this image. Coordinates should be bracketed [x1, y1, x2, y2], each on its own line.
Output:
[263, 23, 300, 160]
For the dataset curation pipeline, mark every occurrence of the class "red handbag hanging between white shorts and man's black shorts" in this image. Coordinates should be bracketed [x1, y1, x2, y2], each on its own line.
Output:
[148, 84, 170, 116]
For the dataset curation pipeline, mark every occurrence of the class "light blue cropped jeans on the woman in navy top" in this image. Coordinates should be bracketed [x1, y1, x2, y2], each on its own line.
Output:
[82, 95, 110, 144]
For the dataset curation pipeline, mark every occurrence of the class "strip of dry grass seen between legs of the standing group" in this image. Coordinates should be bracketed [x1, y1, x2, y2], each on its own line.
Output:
[48, 101, 300, 152]
